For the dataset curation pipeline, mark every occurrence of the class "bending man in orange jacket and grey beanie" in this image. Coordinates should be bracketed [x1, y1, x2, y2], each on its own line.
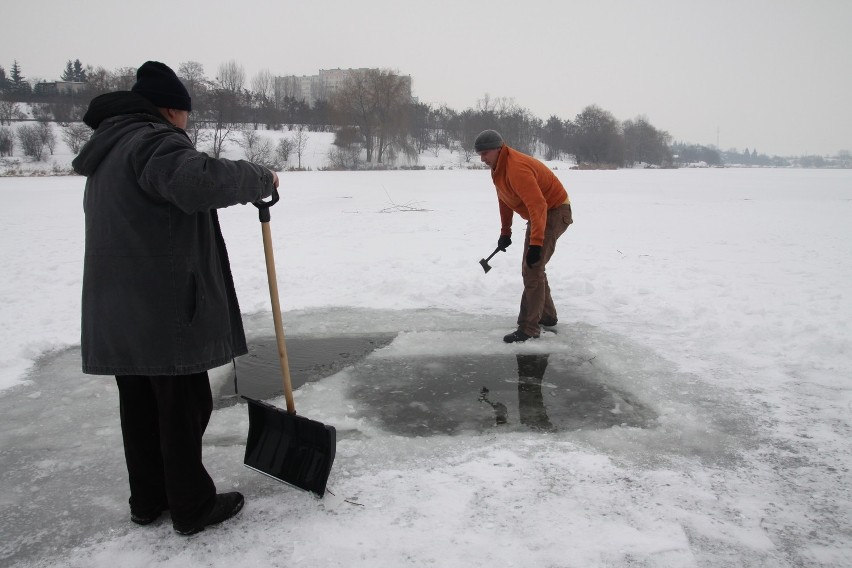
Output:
[474, 130, 572, 343]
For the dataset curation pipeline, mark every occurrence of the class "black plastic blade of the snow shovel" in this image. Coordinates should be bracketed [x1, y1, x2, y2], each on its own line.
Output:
[243, 397, 337, 497]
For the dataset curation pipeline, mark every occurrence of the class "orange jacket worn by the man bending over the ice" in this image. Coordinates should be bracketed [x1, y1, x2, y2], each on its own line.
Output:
[491, 145, 569, 246]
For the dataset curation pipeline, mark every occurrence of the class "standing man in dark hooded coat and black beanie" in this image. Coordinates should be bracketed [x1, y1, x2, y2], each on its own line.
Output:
[73, 61, 278, 534]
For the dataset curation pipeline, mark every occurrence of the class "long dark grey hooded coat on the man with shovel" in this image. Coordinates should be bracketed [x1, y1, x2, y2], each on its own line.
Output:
[73, 92, 273, 375]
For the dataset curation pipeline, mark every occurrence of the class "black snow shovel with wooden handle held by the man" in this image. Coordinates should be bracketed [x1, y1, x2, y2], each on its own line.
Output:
[243, 189, 337, 497]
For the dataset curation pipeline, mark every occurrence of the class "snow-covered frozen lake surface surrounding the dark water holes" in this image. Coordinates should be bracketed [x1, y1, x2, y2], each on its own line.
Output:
[0, 162, 852, 568]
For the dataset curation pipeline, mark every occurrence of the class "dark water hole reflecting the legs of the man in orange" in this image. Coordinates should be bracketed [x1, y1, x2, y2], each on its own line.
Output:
[350, 354, 657, 436]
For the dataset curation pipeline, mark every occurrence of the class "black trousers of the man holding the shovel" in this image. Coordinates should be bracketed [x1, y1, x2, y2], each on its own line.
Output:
[115, 372, 216, 524]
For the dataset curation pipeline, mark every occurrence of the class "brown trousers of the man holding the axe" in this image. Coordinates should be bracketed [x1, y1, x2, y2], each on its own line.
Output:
[518, 203, 573, 337]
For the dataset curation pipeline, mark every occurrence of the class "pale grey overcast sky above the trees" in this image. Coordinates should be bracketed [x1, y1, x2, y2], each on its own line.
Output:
[0, 0, 852, 155]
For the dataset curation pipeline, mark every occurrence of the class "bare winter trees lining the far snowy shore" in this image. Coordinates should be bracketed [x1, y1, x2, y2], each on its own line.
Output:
[0, 59, 832, 169]
